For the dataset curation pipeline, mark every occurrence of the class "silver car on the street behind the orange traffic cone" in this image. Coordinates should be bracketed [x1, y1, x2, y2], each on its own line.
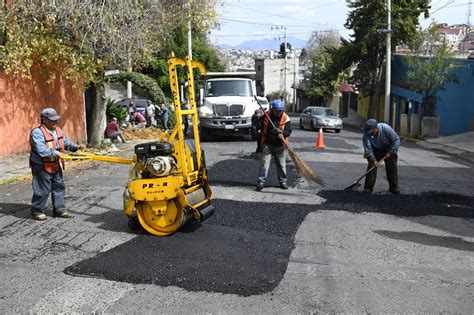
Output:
[300, 106, 342, 133]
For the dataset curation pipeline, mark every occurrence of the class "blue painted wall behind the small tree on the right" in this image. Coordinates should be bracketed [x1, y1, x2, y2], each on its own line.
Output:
[392, 56, 474, 135]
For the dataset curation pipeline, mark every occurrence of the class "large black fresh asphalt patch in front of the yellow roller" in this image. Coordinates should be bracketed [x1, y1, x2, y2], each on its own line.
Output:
[64, 199, 312, 296]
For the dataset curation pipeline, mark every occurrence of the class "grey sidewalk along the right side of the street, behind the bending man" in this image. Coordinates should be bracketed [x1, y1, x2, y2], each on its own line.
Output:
[343, 111, 474, 163]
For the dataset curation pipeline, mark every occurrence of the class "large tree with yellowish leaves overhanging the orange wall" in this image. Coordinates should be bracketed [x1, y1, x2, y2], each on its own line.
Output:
[0, 0, 217, 146]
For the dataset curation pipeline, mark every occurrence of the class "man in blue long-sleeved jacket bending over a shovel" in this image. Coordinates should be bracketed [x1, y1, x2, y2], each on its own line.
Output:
[362, 119, 400, 194]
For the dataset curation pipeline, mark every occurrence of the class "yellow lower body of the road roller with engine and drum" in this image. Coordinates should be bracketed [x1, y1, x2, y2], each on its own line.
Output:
[124, 140, 214, 236]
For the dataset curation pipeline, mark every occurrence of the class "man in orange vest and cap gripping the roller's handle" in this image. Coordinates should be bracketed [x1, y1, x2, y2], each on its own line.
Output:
[30, 108, 85, 220]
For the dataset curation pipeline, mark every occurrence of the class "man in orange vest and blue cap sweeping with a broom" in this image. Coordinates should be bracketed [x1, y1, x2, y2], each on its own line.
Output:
[256, 100, 291, 191]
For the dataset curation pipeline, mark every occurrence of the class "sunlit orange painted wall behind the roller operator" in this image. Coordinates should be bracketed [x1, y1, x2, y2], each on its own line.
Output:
[0, 71, 86, 156]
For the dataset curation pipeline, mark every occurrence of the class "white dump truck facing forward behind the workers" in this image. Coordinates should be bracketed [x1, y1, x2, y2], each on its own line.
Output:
[198, 71, 268, 140]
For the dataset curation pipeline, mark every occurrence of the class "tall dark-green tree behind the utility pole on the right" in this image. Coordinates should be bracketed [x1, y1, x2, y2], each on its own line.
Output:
[341, 0, 430, 118]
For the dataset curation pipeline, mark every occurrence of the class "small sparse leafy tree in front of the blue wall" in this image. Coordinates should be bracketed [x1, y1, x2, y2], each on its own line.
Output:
[405, 23, 458, 116]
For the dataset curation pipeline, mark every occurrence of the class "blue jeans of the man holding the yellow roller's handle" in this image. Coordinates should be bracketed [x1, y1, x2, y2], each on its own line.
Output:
[31, 164, 66, 216]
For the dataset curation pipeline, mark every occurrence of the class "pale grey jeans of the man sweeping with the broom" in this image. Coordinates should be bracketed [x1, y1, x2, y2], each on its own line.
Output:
[257, 144, 288, 184]
